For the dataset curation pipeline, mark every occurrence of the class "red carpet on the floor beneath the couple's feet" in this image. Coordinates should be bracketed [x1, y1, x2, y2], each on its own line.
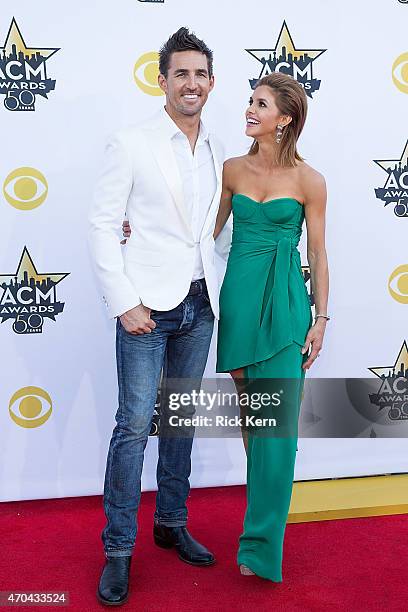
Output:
[0, 487, 408, 612]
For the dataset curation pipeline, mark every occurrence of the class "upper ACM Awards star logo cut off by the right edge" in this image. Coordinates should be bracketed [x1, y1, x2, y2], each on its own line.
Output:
[373, 140, 408, 217]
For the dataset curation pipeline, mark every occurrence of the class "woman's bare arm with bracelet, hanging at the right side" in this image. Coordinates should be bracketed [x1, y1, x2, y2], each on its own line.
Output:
[302, 169, 329, 370]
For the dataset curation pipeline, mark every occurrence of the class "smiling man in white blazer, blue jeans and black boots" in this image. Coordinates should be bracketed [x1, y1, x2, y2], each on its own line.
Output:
[90, 28, 230, 605]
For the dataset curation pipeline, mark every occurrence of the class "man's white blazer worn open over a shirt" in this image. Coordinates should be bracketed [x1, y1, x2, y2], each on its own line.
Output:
[89, 109, 231, 318]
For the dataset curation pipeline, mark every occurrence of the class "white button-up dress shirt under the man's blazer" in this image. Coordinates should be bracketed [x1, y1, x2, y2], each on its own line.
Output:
[163, 107, 217, 280]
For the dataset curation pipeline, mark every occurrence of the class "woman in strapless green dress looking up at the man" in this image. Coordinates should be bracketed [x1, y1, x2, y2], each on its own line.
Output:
[214, 73, 329, 582]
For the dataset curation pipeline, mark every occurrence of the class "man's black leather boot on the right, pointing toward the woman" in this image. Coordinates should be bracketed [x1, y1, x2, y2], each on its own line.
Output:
[153, 525, 215, 565]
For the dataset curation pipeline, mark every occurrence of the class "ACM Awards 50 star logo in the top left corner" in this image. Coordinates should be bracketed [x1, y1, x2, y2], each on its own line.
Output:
[0, 17, 59, 111]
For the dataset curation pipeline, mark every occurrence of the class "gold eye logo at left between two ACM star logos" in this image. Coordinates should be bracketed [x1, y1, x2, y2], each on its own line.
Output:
[3, 167, 48, 210]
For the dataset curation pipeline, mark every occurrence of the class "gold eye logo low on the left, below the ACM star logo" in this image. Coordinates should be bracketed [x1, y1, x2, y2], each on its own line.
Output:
[9, 387, 52, 429]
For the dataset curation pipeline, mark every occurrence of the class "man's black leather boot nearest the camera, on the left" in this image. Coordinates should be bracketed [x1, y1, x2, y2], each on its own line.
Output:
[97, 556, 132, 606]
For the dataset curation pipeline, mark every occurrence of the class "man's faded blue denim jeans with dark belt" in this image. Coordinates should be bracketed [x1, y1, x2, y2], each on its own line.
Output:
[102, 286, 214, 557]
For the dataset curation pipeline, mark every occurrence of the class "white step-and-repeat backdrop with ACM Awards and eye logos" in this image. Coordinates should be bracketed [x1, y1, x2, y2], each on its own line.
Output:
[0, 0, 408, 500]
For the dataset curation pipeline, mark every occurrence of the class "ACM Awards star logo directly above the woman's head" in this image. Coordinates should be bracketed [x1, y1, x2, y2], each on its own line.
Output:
[246, 21, 327, 98]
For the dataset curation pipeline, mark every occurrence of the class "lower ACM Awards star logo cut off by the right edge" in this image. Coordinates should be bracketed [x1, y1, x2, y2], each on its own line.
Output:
[368, 340, 408, 421]
